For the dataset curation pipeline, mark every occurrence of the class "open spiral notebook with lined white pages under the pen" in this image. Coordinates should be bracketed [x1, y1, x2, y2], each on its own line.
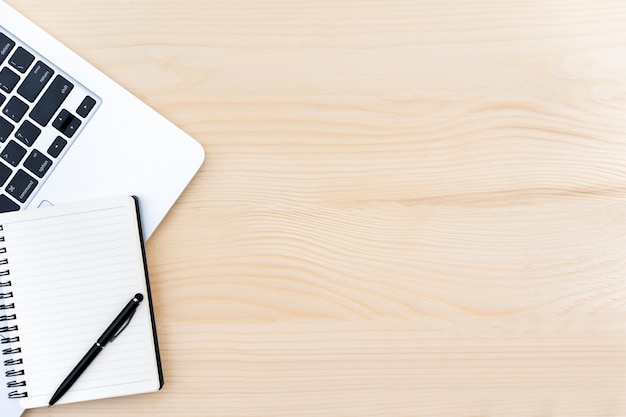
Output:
[0, 196, 163, 406]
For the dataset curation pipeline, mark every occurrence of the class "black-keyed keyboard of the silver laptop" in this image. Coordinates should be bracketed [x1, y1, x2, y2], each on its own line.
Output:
[0, 26, 100, 212]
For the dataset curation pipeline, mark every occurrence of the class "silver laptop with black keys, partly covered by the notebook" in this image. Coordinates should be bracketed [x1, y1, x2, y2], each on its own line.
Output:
[0, 0, 204, 239]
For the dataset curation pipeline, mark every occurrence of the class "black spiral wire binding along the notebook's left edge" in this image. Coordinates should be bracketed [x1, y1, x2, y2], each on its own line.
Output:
[0, 225, 28, 398]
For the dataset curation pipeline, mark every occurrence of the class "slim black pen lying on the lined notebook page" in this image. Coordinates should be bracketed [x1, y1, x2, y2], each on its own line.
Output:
[48, 294, 143, 405]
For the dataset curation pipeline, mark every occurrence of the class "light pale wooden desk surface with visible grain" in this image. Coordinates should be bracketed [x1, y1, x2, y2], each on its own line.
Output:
[8, 0, 626, 417]
